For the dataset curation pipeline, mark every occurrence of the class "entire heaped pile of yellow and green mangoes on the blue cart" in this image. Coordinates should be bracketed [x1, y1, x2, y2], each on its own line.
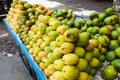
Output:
[6, 0, 120, 80]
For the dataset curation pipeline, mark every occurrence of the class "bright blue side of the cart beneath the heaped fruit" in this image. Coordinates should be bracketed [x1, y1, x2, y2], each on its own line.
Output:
[3, 19, 46, 80]
